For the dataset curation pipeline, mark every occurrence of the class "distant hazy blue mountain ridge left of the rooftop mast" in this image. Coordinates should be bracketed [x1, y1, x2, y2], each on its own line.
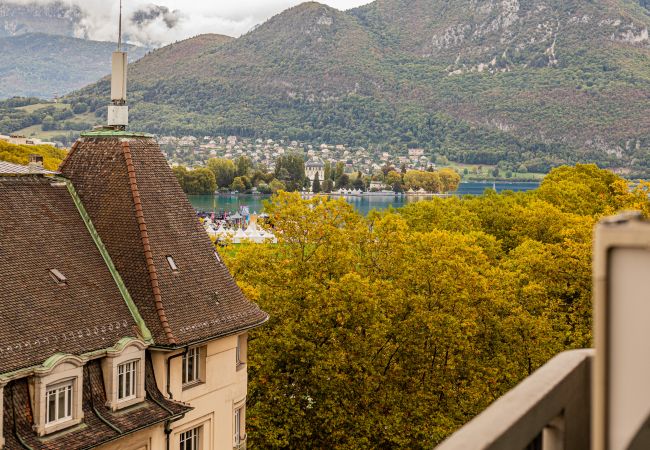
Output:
[0, 33, 147, 98]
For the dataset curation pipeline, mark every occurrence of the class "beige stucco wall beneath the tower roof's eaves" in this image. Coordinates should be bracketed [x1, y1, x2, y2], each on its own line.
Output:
[152, 336, 248, 450]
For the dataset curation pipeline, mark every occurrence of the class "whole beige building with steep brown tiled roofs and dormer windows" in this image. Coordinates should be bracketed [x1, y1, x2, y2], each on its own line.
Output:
[0, 129, 268, 450]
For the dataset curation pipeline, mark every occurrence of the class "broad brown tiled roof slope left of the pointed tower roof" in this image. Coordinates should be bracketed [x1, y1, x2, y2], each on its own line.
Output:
[0, 176, 137, 373]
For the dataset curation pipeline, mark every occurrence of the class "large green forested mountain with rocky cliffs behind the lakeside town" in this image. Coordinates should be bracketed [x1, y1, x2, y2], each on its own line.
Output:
[52, 0, 650, 175]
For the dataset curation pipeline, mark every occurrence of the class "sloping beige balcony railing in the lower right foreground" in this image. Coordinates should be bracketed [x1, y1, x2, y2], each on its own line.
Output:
[437, 349, 594, 450]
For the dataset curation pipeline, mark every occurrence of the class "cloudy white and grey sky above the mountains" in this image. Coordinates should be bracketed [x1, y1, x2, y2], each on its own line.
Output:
[0, 0, 368, 47]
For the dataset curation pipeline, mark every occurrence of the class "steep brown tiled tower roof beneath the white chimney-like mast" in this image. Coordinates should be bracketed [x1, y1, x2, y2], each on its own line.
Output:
[61, 135, 268, 346]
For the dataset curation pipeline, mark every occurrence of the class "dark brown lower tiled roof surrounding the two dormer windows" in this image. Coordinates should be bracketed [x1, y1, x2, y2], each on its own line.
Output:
[3, 356, 191, 450]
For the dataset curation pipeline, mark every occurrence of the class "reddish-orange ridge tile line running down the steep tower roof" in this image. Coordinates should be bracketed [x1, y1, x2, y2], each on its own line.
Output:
[122, 141, 177, 344]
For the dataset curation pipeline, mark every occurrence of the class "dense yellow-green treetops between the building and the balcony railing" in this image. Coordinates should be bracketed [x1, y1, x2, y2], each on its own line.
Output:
[222, 165, 650, 449]
